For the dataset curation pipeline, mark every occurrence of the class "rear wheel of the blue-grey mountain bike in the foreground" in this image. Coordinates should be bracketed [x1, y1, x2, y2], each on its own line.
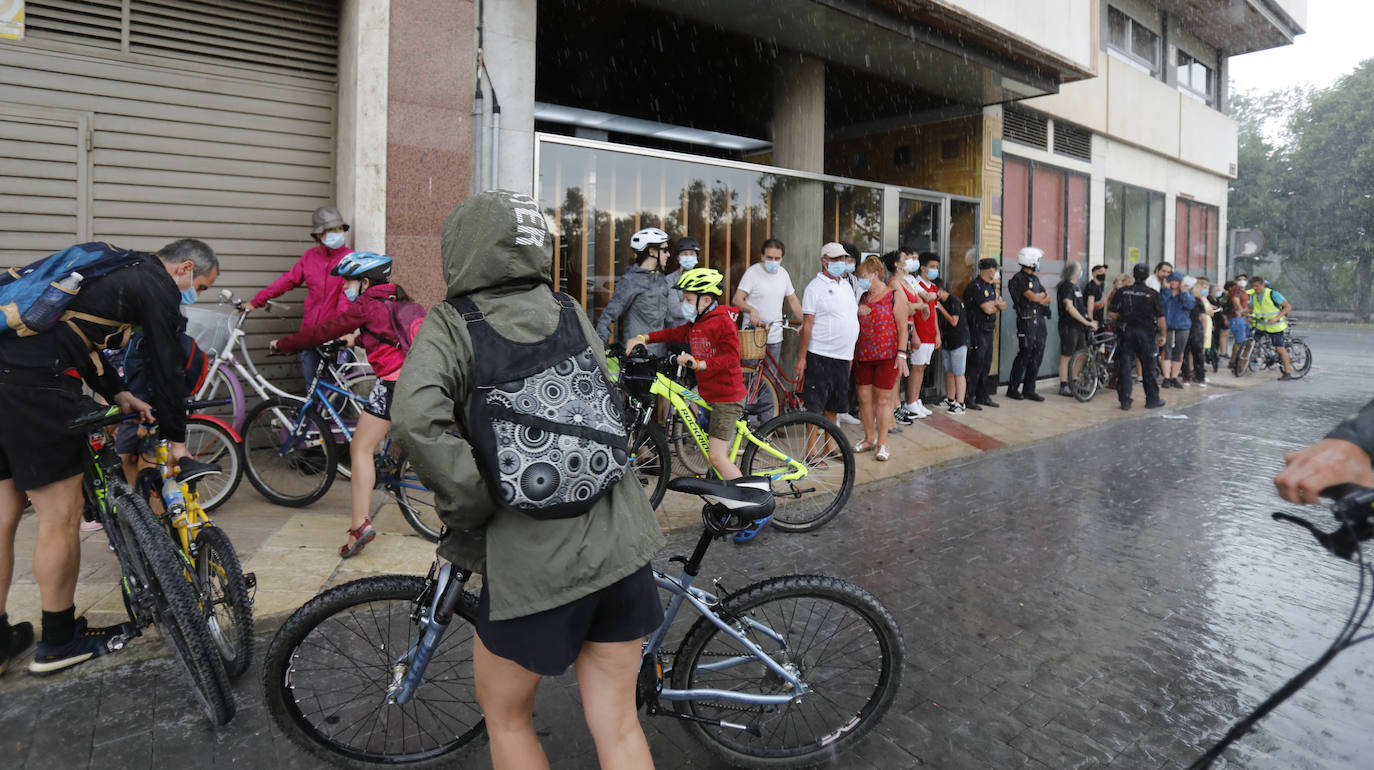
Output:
[672, 575, 904, 767]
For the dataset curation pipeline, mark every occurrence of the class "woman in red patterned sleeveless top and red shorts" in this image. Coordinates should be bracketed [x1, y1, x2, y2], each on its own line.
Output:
[853, 257, 911, 462]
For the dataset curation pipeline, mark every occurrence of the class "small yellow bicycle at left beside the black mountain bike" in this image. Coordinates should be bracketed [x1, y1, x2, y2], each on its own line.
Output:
[135, 402, 257, 678]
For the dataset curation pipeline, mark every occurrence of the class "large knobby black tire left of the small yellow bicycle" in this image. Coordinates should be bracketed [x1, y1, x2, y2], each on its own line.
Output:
[114, 492, 234, 727]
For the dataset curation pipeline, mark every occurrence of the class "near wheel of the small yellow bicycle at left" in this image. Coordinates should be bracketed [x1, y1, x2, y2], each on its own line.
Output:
[195, 524, 253, 679]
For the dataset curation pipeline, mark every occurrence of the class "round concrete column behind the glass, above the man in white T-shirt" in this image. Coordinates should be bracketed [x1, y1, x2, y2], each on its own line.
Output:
[772, 52, 826, 264]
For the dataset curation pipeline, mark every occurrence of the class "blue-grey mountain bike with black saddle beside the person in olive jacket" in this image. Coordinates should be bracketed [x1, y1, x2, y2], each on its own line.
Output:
[262, 477, 905, 769]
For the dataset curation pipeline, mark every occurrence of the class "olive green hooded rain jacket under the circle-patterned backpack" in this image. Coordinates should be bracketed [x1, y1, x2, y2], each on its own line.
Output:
[392, 191, 665, 620]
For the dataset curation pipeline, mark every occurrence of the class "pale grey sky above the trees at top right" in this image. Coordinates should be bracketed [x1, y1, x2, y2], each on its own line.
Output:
[1231, 0, 1374, 91]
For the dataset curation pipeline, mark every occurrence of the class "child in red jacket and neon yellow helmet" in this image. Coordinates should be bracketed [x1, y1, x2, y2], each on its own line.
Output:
[628, 267, 745, 481]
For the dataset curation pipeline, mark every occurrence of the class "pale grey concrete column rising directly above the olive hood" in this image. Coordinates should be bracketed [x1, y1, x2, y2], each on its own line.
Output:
[482, 0, 539, 195]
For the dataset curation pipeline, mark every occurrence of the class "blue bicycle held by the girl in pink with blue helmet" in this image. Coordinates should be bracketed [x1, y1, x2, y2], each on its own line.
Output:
[243, 342, 442, 542]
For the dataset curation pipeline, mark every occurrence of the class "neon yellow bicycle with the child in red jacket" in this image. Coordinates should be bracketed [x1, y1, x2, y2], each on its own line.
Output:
[617, 353, 855, 532]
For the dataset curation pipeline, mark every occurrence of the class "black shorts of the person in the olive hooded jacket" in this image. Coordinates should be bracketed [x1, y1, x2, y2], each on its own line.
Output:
[477, 564, 664, 677]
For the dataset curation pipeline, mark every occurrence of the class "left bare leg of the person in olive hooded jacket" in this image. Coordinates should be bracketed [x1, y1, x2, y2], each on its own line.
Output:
[473, 637, 549, 770]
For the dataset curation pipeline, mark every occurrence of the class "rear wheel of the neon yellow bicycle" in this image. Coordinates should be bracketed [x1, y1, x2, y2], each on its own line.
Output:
[739, 411, 855, 532]
